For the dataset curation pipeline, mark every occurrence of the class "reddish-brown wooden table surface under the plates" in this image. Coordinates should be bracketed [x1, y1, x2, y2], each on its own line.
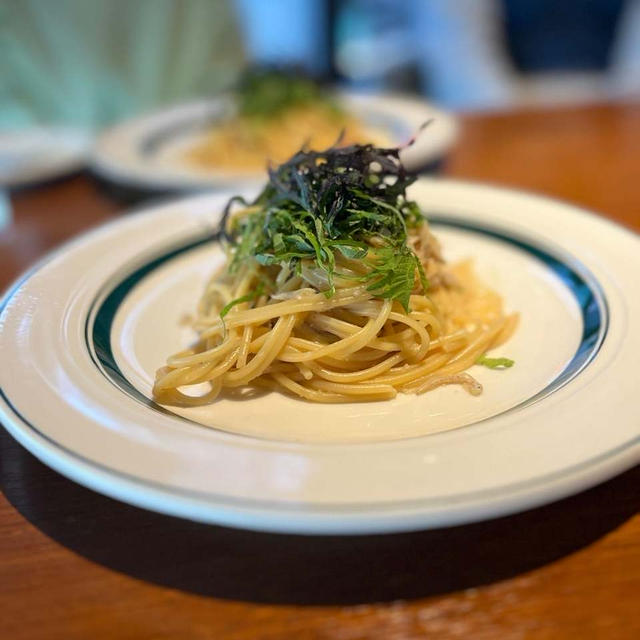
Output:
[0, 104, 640, 640]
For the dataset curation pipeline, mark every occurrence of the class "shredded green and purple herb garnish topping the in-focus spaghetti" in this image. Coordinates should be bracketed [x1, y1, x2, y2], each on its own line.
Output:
[222, 145, 428, 311]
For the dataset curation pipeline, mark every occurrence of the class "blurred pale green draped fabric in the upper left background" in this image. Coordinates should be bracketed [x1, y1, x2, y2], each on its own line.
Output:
[0, 0, 245, 129]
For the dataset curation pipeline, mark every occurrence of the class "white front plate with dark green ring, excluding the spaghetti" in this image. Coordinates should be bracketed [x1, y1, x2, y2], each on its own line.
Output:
[0, 180, 640, 533]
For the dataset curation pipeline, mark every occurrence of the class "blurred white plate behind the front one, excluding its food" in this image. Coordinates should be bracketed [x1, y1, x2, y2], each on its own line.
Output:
[91, 93, 458, 190]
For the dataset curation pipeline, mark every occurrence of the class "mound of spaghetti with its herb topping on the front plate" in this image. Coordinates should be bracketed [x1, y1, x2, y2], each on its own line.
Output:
[154, 145, 517, 406]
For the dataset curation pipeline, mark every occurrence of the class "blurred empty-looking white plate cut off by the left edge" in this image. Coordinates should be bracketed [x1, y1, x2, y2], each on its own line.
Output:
[0, 127, 91, 187]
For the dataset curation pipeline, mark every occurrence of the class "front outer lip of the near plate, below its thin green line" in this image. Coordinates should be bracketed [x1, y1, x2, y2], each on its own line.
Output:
[0, 389, 640, 535]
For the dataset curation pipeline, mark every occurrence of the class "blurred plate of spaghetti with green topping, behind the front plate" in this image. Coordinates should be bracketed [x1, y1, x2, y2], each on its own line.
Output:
[92, 70, 458, 190]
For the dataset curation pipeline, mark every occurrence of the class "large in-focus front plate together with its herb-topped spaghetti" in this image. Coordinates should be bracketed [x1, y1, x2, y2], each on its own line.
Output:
[0, 144, 640, 533]
